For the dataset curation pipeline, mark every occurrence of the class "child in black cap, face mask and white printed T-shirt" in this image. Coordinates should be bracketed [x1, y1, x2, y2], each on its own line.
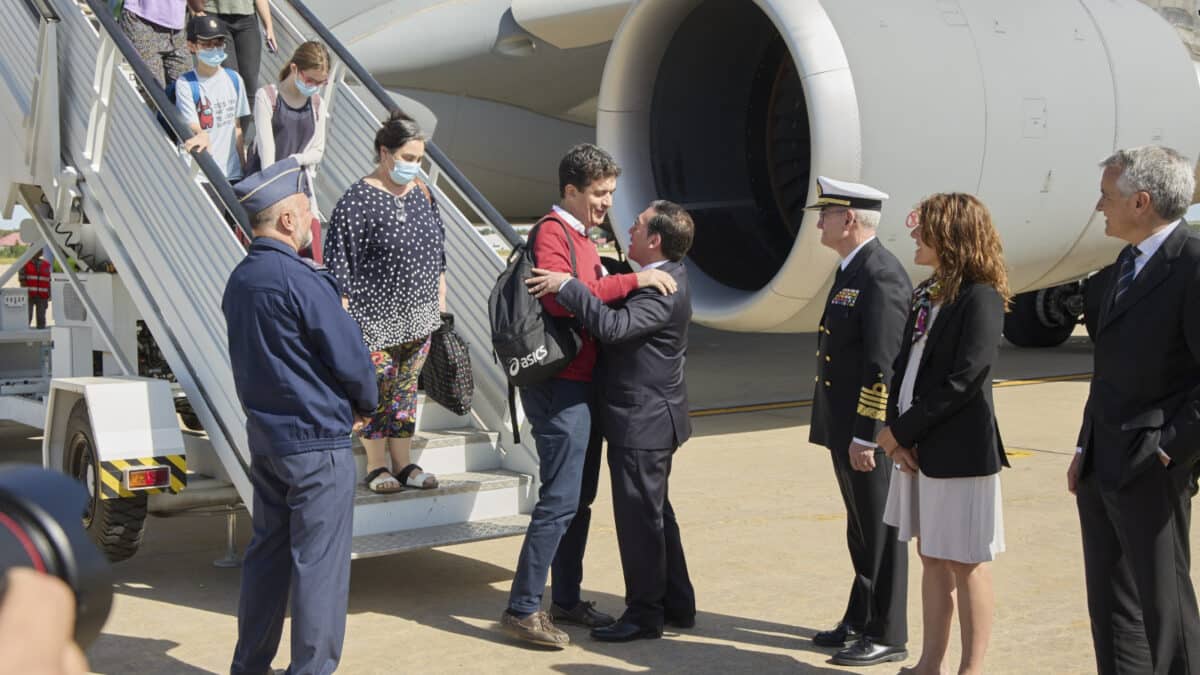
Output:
[175, 16, 250, 184]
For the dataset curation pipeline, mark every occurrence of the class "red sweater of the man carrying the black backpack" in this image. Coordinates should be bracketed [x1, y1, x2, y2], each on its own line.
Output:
[533, 211, 637, 382]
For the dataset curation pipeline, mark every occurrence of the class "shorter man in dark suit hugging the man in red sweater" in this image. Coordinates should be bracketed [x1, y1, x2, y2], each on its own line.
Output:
[528, 201, 696, 643]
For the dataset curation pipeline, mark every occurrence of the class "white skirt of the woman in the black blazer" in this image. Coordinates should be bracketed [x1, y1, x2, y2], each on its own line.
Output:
[883, 461, 1004, 563]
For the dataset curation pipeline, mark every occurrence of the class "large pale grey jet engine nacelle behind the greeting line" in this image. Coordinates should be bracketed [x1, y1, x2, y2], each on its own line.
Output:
[598, 0, 1200, 331]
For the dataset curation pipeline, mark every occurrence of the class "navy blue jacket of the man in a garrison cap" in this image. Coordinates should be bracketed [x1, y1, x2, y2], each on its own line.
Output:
[221, 237, 379, 455]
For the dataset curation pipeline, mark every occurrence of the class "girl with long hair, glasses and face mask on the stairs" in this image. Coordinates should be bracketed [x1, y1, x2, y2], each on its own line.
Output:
[246, 41, 330, 262]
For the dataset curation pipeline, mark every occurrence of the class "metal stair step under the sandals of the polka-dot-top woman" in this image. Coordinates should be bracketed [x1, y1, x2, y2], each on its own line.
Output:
[354, 470, 533, 537]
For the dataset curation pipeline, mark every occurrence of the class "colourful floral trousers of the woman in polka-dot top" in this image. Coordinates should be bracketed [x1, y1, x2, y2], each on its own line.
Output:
[359, 335, 430, 440]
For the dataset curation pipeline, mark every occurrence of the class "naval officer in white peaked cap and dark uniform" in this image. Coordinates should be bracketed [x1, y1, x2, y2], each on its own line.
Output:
[806, 175, 912, 665]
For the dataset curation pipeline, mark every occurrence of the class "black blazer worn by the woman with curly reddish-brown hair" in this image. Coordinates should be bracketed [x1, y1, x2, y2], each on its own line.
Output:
[888, 283, 1008, 478]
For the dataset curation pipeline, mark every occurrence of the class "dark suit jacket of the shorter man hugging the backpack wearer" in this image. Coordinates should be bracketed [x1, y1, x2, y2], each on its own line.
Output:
[558, 262, 691, 449]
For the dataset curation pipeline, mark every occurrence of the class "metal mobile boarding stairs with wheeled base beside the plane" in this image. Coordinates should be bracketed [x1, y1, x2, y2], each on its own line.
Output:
[0, 0, 536, 560]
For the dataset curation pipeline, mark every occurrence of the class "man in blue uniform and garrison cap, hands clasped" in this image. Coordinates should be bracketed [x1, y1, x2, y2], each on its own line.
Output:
[221, 160, 378, 675]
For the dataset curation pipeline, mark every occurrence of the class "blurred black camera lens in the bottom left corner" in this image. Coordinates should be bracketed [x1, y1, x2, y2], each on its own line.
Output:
[0, 466, 113, 649]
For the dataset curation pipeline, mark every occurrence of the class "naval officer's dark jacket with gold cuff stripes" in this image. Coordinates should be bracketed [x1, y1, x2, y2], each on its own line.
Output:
[809, 239, 912, 452]
